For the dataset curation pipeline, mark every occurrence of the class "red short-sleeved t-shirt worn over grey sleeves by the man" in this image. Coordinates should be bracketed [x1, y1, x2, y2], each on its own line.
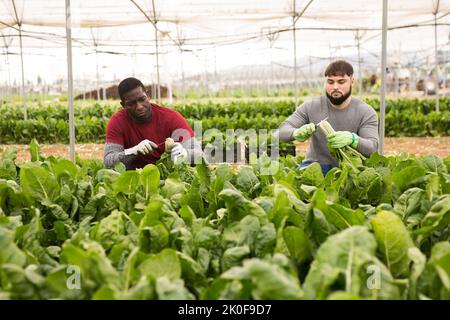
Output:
[106, 103, 194, 168]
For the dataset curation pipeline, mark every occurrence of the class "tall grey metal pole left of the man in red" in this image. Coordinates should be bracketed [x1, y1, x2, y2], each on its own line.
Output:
[66, 0, 75, 162]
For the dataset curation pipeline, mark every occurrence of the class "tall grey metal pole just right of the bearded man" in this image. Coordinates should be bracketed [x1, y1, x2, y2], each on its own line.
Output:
[378, 0, 388, 155]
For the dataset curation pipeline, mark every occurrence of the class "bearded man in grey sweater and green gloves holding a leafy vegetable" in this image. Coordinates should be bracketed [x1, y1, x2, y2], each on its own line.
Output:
[279, 60, 378, 175]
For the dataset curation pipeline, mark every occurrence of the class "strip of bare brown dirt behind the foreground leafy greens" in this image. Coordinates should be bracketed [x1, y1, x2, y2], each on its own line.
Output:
[0, 137, 450, 163]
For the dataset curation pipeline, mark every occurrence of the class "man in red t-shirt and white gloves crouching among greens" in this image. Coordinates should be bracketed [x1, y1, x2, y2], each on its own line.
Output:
[103, 78, 202, 169]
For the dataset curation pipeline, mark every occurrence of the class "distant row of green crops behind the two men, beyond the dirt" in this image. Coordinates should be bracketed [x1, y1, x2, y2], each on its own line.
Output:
[0, 98, 450, 144]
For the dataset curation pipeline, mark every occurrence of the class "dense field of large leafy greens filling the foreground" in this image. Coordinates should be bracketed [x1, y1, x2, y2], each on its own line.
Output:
[0, 142, 450, 299]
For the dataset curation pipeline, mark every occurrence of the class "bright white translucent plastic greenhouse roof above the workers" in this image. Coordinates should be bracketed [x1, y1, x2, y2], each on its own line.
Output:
[0, 0, 450, 81]
